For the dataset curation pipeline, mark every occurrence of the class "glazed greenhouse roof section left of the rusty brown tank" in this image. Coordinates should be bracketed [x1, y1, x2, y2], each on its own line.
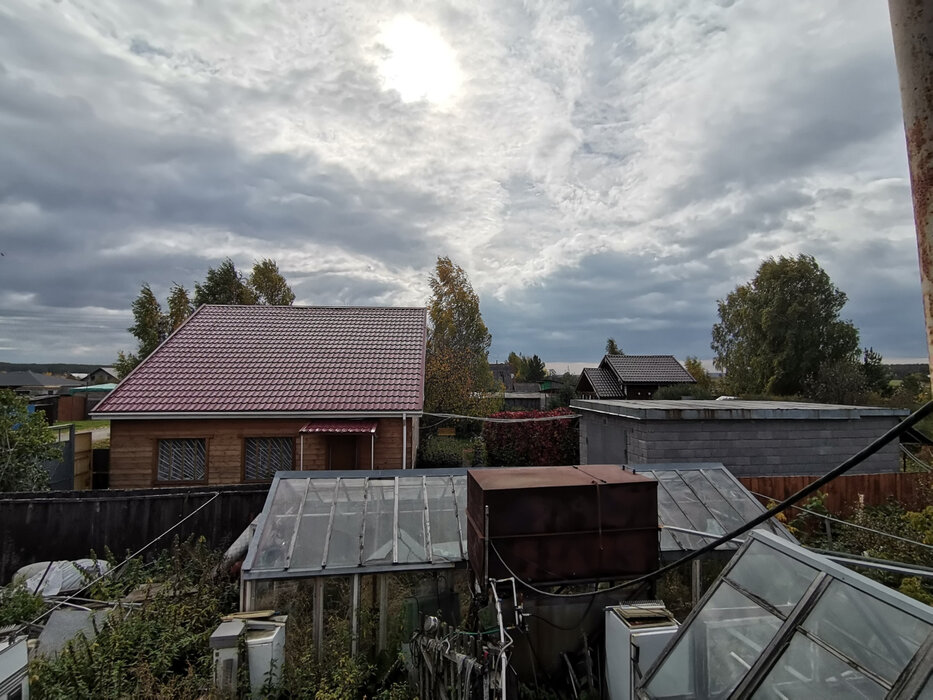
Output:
[243, 469, 467, 580]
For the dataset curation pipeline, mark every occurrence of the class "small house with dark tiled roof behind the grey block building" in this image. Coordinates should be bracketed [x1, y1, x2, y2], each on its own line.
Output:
[577, 355, 696, 400]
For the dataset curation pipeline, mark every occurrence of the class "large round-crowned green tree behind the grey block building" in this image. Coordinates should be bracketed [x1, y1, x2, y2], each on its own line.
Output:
[711, 255, 858, 396]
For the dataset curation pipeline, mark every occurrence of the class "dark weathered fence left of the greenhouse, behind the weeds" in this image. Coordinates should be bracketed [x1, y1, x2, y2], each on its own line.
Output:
[0, 484, 269, 584]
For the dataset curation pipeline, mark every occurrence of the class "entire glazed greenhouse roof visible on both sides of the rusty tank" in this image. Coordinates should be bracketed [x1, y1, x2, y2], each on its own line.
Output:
[243, 464, 795, 580]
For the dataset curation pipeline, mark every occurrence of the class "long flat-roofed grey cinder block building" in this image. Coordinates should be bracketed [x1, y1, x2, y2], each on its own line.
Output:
[571, 400, 908, 476]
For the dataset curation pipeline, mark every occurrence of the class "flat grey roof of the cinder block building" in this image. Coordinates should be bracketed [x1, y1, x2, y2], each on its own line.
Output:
[570, 399, 910, 420]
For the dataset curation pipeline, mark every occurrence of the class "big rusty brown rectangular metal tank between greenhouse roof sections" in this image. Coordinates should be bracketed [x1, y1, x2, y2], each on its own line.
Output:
[467, 465, 658, 583]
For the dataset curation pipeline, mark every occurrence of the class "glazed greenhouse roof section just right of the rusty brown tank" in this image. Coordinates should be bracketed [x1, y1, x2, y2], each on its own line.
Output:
[629, 463, 796, 552]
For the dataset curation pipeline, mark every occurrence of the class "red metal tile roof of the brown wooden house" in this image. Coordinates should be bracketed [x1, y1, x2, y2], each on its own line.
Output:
[94, 306, 426, 415]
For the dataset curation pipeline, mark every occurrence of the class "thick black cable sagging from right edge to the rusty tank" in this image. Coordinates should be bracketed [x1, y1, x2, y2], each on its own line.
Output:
[489, 401, 933, 598]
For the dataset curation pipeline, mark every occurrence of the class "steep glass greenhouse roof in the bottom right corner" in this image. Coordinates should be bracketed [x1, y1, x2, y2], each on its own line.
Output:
[626, 532, 933, 699]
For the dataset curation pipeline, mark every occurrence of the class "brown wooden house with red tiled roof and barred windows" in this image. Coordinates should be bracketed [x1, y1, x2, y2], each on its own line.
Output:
[92, 305, 427, 488]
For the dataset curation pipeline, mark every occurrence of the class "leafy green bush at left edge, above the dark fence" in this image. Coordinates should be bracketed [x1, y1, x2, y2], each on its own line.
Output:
[0, 389, 61, 491]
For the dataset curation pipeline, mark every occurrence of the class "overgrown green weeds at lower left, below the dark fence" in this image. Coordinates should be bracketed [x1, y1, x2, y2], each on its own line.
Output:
[30, 538, 237, 699]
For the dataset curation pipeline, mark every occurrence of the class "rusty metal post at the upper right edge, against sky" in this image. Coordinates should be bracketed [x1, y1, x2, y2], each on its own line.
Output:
[888, 0, 933, 388]
